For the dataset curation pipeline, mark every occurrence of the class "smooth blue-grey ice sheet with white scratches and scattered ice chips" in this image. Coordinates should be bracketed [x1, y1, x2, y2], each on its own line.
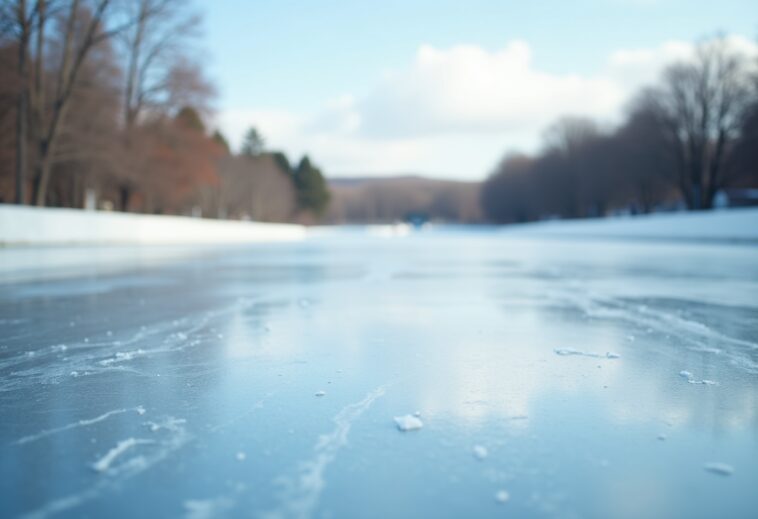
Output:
[0, 233, 758, 518]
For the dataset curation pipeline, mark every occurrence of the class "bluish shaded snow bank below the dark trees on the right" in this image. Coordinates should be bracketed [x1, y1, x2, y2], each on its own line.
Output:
[503, 207, 758, 242]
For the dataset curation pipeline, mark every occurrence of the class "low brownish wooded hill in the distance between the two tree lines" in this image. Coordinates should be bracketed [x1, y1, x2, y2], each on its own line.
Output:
[328, 175, 482, 223]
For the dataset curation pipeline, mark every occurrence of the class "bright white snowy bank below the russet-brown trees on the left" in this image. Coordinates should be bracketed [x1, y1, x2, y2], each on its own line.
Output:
[0, 205, 306, 245]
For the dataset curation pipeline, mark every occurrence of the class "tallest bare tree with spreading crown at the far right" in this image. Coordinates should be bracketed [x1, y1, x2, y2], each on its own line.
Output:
[647, 38, 751, 209]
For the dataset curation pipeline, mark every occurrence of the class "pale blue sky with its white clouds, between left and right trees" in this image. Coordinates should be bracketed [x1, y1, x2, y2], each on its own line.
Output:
[202, 0, 758, 179]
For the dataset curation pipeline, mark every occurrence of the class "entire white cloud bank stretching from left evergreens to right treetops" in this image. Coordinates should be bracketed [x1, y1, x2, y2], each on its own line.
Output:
[219, 37, 758, 179]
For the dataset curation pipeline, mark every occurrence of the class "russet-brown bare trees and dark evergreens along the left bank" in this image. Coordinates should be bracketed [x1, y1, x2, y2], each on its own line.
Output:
[0, 0, 329, 221]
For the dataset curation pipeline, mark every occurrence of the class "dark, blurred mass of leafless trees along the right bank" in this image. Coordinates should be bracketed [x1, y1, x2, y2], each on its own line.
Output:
[481, 37, 758, 223]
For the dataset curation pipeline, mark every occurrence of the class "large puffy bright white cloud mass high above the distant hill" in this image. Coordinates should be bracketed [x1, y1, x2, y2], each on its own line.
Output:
[357, 41, 623, 137]
